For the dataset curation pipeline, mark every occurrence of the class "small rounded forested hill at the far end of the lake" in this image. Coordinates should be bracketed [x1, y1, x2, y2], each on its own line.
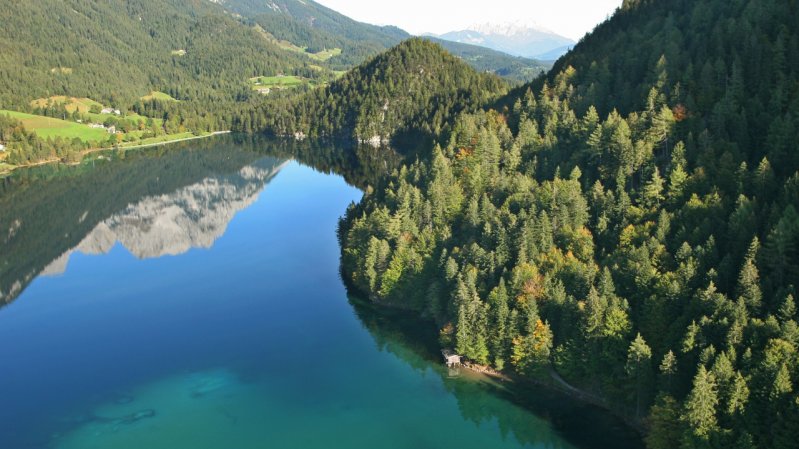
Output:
[237, 38, 506, 141]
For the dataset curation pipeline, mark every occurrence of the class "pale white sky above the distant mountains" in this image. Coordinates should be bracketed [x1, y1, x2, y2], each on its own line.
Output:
[316, 0, 622, 40]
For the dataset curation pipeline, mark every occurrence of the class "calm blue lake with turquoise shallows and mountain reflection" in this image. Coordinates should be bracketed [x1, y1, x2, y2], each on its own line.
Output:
[0, 136, 642, 449]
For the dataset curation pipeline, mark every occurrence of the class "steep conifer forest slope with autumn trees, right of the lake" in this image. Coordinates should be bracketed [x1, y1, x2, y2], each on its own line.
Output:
[340, 0, 799, 449]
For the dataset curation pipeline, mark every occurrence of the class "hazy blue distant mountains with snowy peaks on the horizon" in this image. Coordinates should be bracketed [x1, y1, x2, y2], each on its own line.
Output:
[428, 22, 575, 61]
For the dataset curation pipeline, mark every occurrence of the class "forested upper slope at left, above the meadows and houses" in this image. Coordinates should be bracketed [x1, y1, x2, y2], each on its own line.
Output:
[0, 0, 318, 109]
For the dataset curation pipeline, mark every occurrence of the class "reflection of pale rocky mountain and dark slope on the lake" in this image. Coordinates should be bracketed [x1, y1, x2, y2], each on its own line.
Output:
[0, 136, 400, 305]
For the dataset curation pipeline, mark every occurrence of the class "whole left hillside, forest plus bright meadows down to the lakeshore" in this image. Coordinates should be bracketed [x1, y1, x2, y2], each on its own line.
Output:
[0, 0, 335, 169]
